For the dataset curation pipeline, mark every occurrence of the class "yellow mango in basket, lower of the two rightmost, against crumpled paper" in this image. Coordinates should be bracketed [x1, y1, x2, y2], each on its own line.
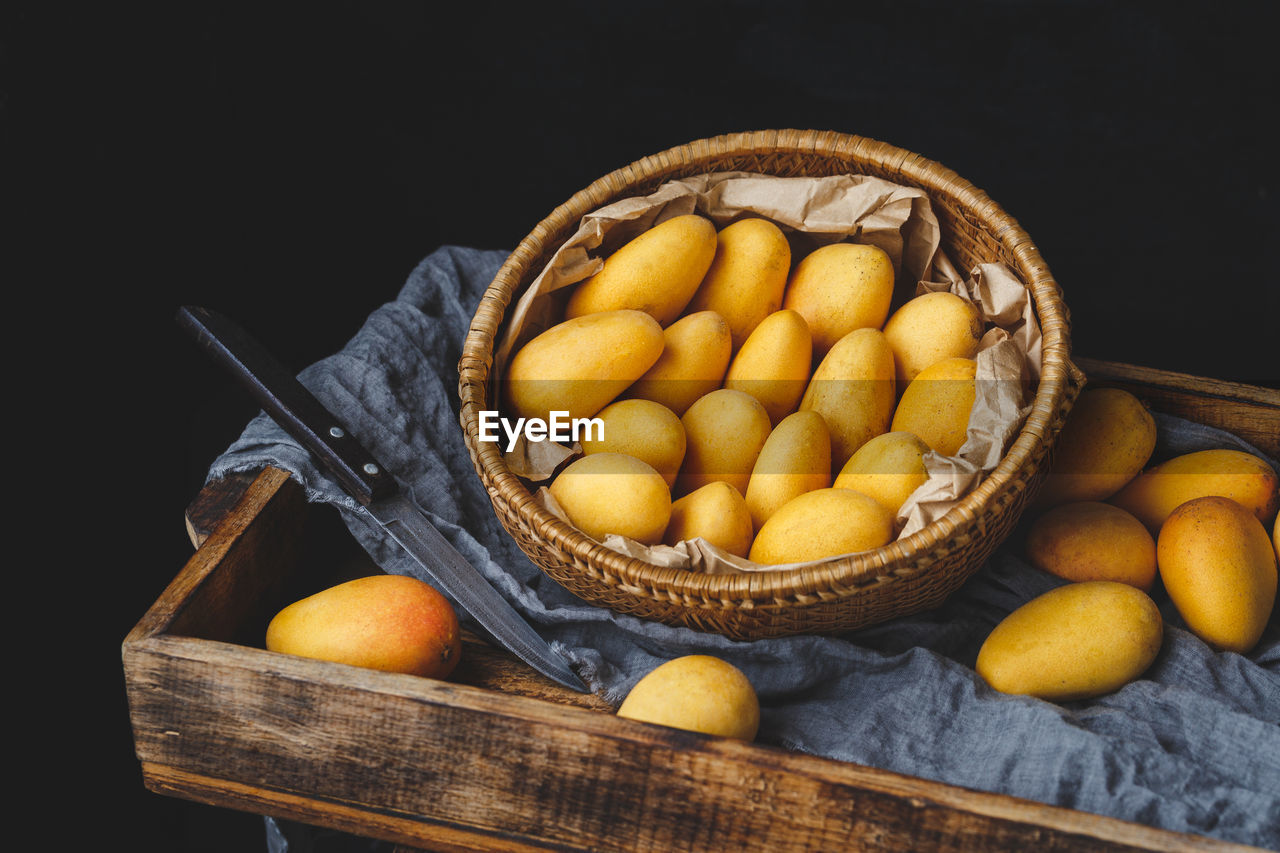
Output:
[890, 359, 978, 456]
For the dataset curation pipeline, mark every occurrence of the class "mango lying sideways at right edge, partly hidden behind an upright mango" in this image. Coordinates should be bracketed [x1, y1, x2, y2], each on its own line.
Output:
[1110, 450, 1280, 534]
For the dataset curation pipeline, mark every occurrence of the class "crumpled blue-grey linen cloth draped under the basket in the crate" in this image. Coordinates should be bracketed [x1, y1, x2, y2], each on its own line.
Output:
[210, 247, 1280, 849]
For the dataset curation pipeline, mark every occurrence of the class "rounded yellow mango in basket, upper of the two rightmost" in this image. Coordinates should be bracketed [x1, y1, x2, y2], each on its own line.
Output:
[883, 291, 982, 388]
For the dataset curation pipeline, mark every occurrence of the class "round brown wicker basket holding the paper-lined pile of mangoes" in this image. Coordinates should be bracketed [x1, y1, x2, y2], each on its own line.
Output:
[458, 131, 1083, 639]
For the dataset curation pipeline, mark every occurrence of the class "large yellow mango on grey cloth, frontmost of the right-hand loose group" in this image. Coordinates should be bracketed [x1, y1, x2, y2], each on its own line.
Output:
[974, 580, 1165, 702]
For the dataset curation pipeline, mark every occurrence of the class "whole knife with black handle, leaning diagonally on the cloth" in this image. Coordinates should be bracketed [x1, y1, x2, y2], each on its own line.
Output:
[178, 305, 590, 693]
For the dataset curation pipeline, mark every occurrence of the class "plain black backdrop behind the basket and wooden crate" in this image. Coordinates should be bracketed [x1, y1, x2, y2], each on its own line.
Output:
[0, 0, 1280, 850]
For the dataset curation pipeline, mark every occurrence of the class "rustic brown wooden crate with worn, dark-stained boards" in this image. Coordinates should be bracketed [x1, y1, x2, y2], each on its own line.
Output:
[123, 360, 1280, 852]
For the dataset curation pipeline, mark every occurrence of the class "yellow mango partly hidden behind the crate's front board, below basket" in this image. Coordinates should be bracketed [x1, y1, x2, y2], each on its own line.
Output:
[617, 654, 760, 742]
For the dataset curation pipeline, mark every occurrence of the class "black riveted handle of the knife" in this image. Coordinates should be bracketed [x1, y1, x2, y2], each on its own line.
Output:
[178, 305, 397, 506]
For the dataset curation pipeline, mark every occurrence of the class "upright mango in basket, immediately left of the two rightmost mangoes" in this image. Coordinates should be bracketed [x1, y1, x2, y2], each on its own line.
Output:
[800, 329, 895, 470]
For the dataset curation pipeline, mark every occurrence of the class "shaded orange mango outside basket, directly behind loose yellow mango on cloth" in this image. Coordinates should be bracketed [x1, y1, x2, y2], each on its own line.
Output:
[1025, 501, 1156, 592]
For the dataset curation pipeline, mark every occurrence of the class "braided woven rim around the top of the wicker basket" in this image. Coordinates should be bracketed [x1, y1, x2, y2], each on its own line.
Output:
[458, 129, 1079, 607]
